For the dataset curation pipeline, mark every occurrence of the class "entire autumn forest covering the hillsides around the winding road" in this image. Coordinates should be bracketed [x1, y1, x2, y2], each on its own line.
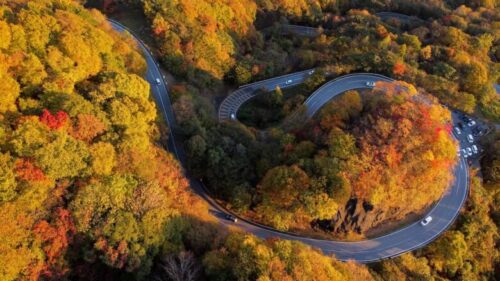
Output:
[0, 0, 500, 281]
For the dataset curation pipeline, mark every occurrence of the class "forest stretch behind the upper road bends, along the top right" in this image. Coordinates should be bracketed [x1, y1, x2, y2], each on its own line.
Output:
[144, 0, 500, 118]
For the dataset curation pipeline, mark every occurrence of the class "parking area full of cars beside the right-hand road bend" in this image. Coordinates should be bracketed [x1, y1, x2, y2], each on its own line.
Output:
[452, 111, 490, 165]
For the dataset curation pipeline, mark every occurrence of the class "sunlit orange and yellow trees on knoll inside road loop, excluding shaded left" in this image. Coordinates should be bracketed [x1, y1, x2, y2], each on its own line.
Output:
[237, 82, 457, 233]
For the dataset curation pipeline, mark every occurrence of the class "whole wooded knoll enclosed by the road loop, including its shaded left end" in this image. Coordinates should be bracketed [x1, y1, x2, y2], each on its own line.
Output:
[183, 82, 457, 234]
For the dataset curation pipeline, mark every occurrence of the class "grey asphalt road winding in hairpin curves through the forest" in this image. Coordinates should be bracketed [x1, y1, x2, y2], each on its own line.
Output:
[110, 21, 469, 263]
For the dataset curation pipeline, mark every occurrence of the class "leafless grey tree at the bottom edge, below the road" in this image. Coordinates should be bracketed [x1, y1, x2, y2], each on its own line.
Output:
[155, 251, 200, 281]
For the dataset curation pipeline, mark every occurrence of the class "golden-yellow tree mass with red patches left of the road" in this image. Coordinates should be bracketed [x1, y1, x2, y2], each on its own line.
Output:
[0, 0, 191, 281]
